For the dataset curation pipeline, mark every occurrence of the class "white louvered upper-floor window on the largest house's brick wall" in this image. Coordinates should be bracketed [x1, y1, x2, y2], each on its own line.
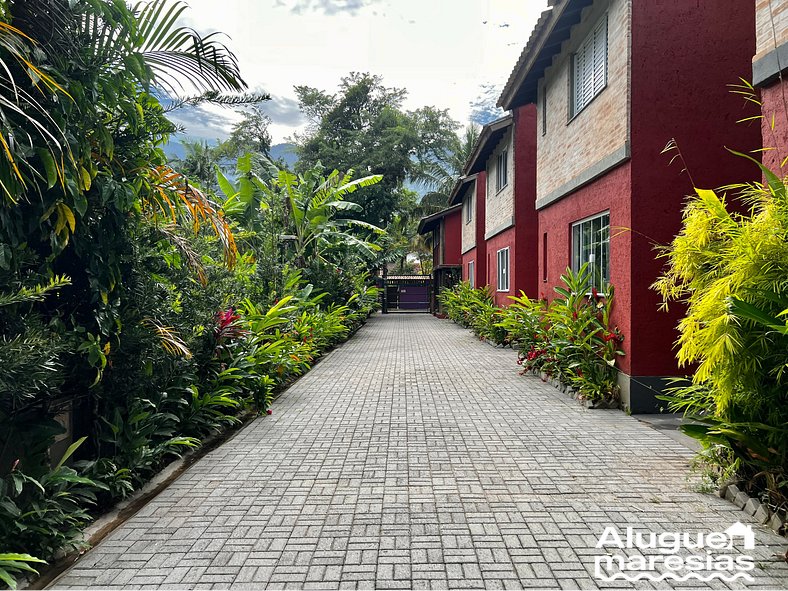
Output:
[571, 15, 607, 117]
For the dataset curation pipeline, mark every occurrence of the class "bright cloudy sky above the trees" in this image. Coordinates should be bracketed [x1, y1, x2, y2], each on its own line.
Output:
[171, 0, 547, 144]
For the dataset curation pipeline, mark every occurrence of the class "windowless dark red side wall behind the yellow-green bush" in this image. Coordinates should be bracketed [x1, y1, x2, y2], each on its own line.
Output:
[632, 0, 761, 376]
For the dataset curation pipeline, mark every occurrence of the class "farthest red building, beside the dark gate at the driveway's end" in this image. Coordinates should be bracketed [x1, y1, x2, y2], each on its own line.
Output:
[418, 205, 462, 313]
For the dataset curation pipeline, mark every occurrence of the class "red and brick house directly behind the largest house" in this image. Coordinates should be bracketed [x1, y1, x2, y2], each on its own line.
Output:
[463, 105, 537, 306]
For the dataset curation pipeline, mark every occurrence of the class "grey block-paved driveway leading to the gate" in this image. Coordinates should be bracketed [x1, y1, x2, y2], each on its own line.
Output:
[56, 315, 788, 589]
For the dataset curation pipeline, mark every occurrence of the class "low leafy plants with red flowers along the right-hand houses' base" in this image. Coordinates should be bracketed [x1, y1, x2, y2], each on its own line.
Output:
[440, 266, 624, 401]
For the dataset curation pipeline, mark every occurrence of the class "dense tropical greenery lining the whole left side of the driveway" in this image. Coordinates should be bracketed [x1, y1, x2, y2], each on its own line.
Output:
[0, 0, 380, 586]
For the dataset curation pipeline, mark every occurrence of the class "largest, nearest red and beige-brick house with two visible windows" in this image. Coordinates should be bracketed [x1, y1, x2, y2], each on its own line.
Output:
[498, 0, 760, 412]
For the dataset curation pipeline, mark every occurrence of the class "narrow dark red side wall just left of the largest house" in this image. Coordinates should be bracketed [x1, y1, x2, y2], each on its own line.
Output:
[512, 104, 539, 298]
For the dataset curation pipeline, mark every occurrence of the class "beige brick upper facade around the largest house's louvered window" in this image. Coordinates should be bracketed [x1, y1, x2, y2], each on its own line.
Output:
[536, 0, 631, 207]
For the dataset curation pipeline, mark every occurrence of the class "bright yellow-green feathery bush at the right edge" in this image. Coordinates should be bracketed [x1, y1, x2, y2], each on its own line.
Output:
[654, 167, 788, 509]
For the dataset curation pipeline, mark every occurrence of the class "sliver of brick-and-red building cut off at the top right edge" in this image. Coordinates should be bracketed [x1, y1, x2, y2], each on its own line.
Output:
[748, 0, 788, 169]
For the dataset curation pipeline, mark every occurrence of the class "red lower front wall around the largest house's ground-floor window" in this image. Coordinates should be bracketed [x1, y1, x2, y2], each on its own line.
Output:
[538, 162, 632, 373]
